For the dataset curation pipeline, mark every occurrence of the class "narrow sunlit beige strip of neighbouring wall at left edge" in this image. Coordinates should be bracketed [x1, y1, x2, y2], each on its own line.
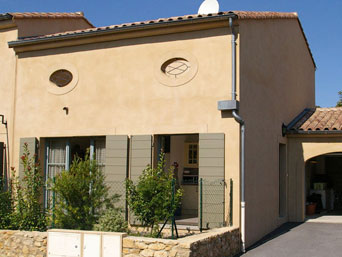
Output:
[0, 22, 17, 173]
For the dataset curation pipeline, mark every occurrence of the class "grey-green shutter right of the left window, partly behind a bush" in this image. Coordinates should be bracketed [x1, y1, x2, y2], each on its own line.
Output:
[105, 135, 128, 213]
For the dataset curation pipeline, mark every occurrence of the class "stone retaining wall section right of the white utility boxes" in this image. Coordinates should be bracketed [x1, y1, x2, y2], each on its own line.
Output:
[123, 228, 241, 257]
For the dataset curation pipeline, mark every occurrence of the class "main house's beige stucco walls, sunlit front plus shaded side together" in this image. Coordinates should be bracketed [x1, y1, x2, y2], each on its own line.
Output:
[5, 15, 315, 245]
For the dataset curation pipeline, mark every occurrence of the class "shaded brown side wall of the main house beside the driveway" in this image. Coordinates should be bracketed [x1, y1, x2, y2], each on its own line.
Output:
[239, 19, 315, 246]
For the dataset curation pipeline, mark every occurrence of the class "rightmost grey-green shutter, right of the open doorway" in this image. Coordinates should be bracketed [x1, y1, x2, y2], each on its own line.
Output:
[199, 133, 225, 228]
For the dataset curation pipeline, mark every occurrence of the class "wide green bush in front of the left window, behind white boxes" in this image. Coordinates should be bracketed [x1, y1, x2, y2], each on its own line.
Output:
[52, 152, 113, 230]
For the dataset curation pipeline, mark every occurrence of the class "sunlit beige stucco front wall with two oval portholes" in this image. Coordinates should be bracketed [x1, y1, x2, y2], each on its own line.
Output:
[12, 27, 239, 225]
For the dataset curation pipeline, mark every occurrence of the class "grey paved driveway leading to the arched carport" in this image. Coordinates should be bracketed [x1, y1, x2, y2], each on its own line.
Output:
[240, 222, 342, 257]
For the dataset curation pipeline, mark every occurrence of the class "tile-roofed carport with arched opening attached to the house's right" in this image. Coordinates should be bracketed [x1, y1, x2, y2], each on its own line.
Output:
[287, 108, 342, 222]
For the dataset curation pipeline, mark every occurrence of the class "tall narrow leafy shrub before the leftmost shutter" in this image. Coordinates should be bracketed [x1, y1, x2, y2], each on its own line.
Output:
[11, 143, 46, 231]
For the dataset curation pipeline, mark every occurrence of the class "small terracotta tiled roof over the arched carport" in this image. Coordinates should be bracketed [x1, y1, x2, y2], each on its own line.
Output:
[288, 107, 342, 133]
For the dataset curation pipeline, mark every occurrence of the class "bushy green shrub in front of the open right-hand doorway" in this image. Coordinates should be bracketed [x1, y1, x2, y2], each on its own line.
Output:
[126, 154, 182, 235]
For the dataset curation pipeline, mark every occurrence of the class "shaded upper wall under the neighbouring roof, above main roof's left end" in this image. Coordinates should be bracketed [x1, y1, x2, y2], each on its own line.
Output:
[15, 18, 93, 38]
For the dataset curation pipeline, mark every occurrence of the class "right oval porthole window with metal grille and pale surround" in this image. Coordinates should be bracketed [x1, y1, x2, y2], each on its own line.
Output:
[155, 50, 198, 87]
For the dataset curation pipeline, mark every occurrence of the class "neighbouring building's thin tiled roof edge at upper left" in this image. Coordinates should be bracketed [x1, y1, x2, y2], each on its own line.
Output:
[0, 12, 94, 27]
